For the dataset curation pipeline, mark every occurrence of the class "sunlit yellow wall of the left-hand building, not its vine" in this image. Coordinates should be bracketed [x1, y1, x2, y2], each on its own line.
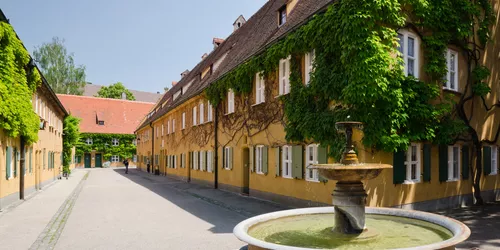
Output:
[0, 10, 67, 209]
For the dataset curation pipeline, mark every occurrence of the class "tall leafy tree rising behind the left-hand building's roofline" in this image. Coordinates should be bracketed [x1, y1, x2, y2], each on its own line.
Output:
[33, 37, 85, 95]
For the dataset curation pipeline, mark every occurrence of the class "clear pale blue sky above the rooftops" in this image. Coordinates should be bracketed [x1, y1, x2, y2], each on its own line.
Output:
[0, 0, 268, 92]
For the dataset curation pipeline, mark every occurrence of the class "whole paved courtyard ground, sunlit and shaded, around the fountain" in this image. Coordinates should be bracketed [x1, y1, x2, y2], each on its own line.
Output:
[0, 169, 500, 250]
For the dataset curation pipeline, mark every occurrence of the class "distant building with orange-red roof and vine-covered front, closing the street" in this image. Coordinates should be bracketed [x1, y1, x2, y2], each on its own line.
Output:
[58, 94, 154, 168]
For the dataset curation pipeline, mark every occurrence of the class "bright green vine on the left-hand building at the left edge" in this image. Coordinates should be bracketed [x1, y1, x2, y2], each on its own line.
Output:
[0, 21, 41, 144]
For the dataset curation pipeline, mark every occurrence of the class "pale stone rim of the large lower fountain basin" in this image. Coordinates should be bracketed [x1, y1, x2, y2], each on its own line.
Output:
[233, 207, 471, 250]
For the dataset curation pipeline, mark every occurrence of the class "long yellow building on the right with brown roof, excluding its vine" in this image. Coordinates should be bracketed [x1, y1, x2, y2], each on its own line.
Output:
[136, 0, 500, 210]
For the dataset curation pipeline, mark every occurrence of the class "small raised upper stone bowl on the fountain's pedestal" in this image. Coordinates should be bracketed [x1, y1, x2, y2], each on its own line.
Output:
[308, 163, 392, 182]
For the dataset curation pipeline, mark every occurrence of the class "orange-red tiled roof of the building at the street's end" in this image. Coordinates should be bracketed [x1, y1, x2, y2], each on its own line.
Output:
[57, 94, 154, 134]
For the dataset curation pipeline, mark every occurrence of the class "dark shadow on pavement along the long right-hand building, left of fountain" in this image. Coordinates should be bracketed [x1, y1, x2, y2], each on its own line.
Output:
[113, 168, 288, 233]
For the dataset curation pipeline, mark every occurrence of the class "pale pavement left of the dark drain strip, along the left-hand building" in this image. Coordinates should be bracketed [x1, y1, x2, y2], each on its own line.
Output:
[0, 170, 87, 250]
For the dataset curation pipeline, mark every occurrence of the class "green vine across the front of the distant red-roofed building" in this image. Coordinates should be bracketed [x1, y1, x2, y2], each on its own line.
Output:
[76, 133, 136, 159]
